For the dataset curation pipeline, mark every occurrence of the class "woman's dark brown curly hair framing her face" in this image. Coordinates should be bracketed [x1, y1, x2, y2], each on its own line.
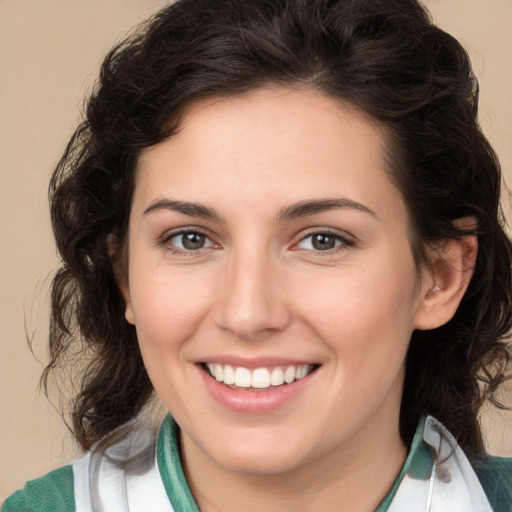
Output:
[46, 0, 512, 453]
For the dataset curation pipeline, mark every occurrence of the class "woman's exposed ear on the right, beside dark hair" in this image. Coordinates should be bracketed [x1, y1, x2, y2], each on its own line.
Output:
[414, 217, 478, 330]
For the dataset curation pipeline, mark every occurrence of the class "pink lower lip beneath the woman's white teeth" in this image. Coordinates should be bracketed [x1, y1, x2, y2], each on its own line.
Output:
[198, 365, 318, 414]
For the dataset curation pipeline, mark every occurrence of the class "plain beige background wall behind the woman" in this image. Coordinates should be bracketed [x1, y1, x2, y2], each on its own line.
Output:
[0, 0, 512, 502]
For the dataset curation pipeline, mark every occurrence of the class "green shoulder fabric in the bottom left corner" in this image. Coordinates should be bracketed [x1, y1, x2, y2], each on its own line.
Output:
[0, 466, 75, 512]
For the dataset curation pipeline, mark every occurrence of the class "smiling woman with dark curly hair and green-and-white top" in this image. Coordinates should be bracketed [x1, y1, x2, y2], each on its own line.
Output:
[2, 0, 512, 512]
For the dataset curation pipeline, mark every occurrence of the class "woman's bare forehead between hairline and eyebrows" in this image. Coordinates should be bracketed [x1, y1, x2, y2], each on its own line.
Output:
[136, 88, 403, 222]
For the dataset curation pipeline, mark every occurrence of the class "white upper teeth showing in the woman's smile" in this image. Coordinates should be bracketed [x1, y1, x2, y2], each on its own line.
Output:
[206, 363, 313, 389]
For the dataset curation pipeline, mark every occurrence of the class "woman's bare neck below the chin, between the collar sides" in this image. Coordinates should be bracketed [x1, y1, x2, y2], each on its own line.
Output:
[181, 412, 407, 512]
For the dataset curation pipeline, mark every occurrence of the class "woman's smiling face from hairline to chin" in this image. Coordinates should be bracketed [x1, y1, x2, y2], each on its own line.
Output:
[123, 89, 432, 474]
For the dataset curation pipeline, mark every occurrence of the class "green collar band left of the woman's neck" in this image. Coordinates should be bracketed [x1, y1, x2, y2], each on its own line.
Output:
[156, 414, 199, 512]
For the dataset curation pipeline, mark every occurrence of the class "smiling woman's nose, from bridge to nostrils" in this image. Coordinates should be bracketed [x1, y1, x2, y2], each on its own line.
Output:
[215, 251, 291, 340]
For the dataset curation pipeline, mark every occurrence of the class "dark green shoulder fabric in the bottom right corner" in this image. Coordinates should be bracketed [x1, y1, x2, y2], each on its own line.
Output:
[471, 457, 512, 512]
